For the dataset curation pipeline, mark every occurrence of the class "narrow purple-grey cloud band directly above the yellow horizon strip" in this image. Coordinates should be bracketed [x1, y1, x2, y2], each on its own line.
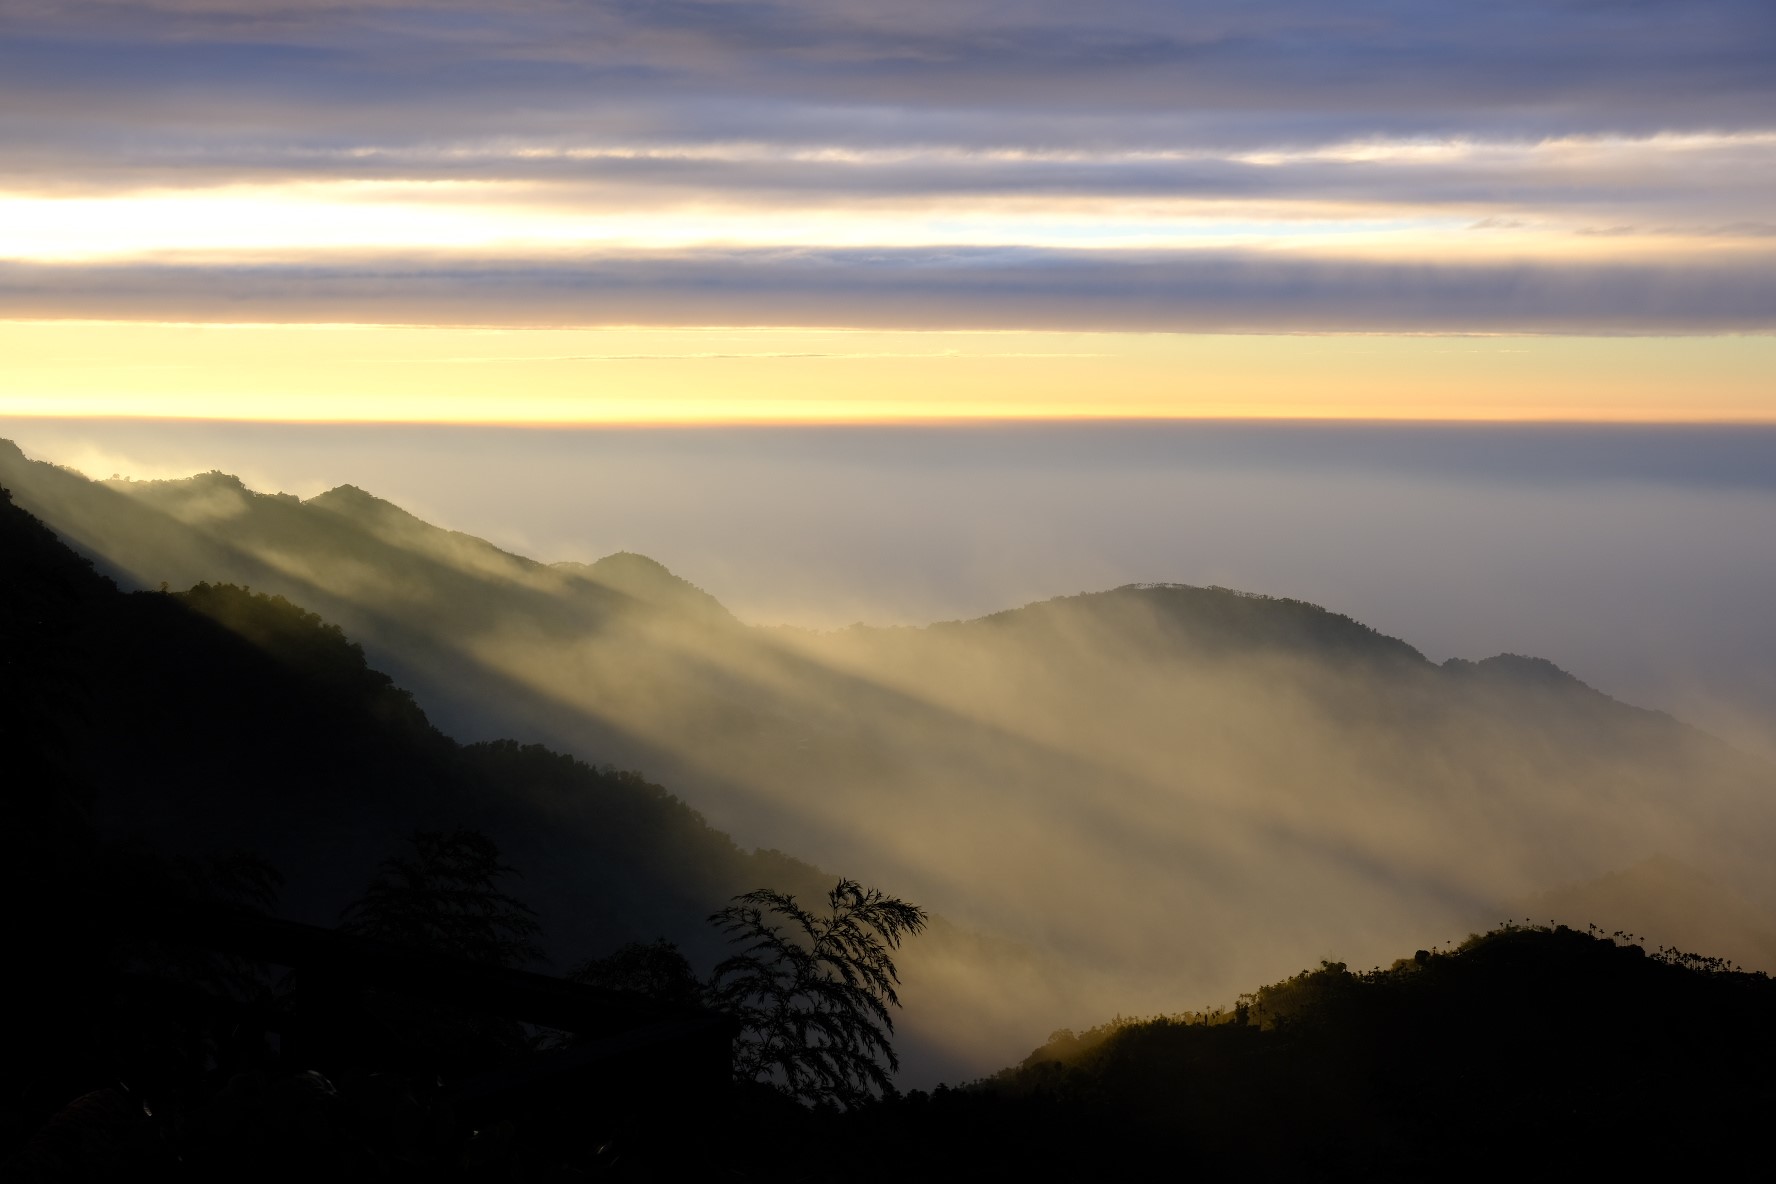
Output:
[0, 249, 1776, 334]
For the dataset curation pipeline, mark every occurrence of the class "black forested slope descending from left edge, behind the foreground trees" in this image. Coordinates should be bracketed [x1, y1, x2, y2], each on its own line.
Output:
[0, 482, 817, 962]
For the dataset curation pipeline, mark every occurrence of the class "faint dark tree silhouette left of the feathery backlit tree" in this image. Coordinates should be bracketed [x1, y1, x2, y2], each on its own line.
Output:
[339, 829, 542, 966]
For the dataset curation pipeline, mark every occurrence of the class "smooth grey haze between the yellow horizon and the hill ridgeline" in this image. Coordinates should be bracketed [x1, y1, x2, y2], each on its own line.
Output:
[13, 411, 1776, 754]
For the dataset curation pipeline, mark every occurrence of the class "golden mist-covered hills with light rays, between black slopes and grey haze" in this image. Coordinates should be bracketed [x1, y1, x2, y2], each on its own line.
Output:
[0, 446, 1776, 1070]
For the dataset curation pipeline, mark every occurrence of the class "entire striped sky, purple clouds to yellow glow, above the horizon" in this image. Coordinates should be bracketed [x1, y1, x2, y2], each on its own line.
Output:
[0, 0, 1776, 424]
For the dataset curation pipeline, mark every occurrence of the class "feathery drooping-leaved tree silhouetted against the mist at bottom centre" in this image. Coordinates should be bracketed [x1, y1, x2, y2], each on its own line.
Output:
[709, 880, 925, 1109]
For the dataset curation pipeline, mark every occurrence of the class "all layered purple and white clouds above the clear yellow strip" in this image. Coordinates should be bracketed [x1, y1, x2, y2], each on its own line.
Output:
[0, 0, 1776, 332]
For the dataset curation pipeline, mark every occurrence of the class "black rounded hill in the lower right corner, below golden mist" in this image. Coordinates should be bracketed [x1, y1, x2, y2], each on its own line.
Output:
[831, 928, 1776, 1180]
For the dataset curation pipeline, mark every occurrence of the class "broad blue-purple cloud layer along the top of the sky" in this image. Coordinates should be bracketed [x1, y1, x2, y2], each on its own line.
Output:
[0, 0, 1776, 162]
